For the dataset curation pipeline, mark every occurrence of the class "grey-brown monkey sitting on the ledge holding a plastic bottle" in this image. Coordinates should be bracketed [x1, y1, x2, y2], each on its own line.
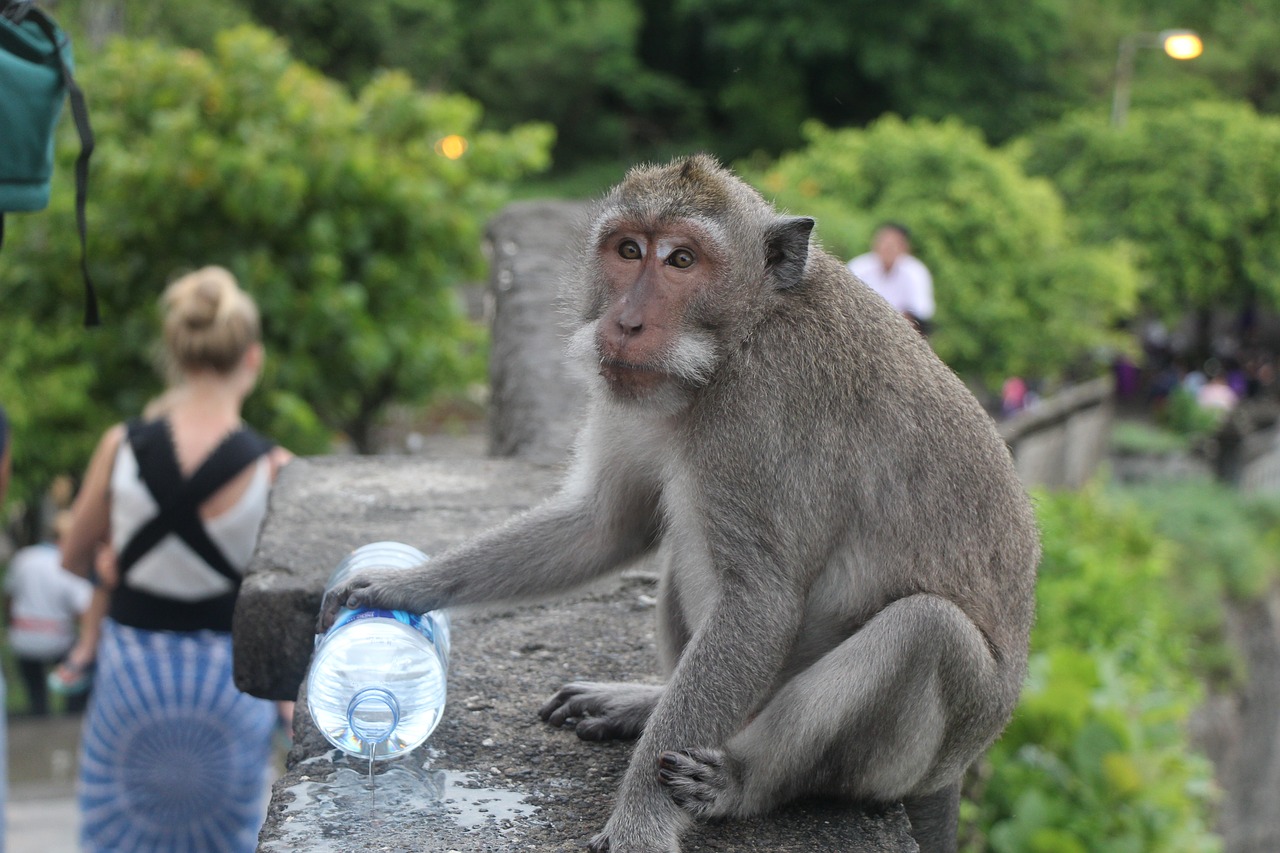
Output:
[320, 154, 1039, 853]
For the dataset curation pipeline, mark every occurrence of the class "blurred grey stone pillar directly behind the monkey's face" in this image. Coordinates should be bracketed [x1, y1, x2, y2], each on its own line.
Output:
[485, 201, 589, 462]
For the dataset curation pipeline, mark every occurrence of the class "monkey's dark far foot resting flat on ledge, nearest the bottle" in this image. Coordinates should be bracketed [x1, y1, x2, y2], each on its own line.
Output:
[538, 681, 663, 740]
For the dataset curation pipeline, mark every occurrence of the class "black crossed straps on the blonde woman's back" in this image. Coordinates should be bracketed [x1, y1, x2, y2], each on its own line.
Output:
[119, 420, 273, 584]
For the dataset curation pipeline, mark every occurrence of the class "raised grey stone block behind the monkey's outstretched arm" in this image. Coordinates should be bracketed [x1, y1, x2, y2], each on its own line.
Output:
[233, 456, 558, 699]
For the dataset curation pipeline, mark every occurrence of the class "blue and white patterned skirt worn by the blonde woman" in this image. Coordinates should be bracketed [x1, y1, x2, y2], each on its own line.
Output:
[79, 619, 275, 853]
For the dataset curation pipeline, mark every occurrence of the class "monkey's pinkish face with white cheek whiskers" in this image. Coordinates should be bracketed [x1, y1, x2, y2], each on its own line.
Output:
[593, 220, 719, 400]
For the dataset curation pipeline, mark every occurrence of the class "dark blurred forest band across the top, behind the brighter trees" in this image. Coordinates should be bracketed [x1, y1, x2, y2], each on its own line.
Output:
[56, 0, 1280, 174]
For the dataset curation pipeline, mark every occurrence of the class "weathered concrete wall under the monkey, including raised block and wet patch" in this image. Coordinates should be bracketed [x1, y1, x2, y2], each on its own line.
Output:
[236, 457, 916, 853]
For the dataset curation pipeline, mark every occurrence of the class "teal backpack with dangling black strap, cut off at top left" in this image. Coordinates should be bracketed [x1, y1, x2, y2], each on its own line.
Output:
[0, 0, 99, 325]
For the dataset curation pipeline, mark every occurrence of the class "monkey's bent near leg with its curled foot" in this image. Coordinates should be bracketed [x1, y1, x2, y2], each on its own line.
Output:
[659, 594, 1010, 850]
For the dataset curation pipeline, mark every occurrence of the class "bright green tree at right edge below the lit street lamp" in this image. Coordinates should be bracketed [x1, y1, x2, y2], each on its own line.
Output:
[1021, 102, 1280, 316]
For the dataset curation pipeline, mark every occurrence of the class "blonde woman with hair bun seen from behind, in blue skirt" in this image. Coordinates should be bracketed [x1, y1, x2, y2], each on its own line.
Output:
[63, 266, 289, 853]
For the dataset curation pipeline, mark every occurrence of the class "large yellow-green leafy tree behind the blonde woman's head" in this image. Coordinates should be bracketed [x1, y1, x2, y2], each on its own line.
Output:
[0, 28, 552, 499]
